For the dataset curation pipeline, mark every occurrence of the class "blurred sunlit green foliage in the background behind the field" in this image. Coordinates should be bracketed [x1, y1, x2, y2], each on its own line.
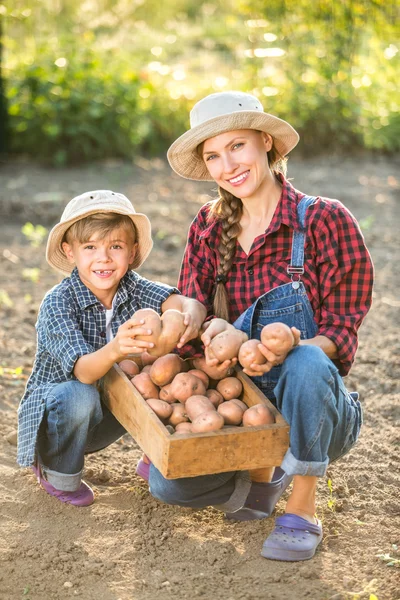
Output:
[0, 0, 400, 165]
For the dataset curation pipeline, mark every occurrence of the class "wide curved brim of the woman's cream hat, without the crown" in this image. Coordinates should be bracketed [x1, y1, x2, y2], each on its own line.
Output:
[167, 110, 300, 181]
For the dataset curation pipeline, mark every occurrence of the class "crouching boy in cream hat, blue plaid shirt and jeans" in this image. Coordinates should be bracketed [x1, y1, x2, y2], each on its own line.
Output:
[17, 190, 206, 506]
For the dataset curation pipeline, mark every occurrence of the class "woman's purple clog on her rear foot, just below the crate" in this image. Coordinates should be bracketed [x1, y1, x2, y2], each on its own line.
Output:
[225, 467, 293, 521]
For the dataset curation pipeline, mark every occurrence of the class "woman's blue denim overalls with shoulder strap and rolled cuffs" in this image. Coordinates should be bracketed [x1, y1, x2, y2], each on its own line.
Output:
[149, 196, 362, 512]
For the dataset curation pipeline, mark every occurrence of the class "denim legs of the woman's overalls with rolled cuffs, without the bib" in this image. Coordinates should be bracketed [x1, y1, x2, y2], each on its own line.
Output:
[149, 345, 362, 512]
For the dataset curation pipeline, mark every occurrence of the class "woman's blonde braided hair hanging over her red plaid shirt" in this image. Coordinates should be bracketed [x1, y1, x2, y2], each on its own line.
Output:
[197, 135, 287, 321]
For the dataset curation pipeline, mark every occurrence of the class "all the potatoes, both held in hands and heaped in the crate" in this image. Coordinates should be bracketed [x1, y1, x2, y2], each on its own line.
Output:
[119, 322, 295, 433]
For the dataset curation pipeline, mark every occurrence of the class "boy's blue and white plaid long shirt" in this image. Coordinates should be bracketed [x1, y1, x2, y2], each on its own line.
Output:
[17, 269, 179, 467]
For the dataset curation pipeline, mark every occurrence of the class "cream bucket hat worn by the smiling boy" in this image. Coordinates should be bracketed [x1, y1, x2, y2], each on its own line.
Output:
[46, 190, 153, 275]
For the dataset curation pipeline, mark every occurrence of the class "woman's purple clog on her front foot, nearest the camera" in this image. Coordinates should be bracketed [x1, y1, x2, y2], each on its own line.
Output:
[261, 513, 322, 561]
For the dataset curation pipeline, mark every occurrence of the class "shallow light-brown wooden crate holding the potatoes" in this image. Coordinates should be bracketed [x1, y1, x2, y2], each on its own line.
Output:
[104, 365, 289, 479]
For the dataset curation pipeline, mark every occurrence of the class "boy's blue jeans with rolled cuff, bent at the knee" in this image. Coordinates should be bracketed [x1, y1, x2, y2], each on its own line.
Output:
[37, 380, 126, 491]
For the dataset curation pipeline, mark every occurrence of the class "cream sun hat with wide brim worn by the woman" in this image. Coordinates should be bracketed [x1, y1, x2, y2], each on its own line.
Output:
[167, 92, 299, 181]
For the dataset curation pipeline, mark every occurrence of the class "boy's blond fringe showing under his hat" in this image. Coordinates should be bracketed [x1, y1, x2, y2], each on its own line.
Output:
[62, 213, 137, 244]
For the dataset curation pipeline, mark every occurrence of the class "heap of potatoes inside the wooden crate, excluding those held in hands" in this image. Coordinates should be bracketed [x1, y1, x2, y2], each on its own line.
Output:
[119, 354, 274, 434]
